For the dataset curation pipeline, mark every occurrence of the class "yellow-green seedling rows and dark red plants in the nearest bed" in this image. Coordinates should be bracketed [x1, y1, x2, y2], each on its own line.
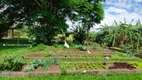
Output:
[61, 62, 136, 71]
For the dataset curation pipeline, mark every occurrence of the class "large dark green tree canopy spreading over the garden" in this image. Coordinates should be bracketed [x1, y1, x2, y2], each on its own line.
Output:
[0, 0, 104, 44]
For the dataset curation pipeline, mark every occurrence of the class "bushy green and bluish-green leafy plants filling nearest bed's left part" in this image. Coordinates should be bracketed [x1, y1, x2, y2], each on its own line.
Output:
[0, 55, 57, 71]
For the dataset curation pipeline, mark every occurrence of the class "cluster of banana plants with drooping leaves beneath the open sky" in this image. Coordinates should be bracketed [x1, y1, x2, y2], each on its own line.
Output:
[96, 19, 142, 52]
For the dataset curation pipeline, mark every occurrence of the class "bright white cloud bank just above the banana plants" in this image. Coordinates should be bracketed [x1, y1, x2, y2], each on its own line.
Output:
[104, 7, 142, 25]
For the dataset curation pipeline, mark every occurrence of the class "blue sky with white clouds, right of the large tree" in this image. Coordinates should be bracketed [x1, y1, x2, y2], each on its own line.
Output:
[91, 0, 142, 31]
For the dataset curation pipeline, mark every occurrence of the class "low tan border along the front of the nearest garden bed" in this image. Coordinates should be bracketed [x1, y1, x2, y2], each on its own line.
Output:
[0, 69, 142, 77]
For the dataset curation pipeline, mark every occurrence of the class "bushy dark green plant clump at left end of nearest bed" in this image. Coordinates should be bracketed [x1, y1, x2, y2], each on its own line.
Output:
[0, 55, 22, 71]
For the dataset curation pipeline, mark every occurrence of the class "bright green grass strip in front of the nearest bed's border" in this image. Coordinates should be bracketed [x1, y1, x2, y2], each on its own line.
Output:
[0, 74, 142, 80]
